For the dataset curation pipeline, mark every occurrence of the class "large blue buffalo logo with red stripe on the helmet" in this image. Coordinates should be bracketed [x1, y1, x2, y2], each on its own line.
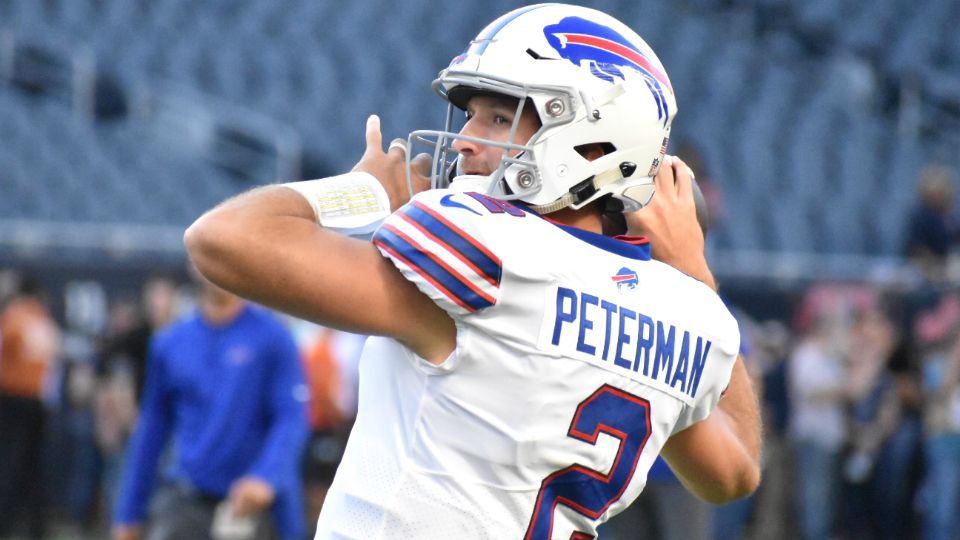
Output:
[543, 17, 673, 123]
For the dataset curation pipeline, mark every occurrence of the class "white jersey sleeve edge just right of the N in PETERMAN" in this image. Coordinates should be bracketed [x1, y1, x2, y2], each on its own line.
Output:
[673, 308, 740, 433]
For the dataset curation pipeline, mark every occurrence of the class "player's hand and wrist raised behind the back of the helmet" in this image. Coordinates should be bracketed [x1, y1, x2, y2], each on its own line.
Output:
[625, 156, 716, 288]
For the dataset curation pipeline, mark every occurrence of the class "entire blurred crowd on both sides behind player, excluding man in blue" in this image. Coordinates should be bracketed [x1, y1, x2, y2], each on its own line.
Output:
[0, 161, 960, 539]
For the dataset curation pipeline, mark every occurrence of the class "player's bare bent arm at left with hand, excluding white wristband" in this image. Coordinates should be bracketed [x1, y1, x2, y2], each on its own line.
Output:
[184, 117, 456, 362]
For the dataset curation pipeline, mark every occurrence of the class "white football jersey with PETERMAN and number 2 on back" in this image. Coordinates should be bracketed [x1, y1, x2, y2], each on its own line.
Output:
[317, 190, 740, 540]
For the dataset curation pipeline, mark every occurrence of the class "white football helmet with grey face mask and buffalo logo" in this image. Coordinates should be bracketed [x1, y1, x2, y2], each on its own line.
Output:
[408, 4, 677, 213]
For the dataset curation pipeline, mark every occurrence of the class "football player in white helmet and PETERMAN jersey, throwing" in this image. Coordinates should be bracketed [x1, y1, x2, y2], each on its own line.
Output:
[185, 4, 760, 539]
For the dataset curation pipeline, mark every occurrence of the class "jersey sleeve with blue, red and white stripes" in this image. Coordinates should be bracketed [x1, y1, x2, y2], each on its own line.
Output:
[373, 190, 503, 316]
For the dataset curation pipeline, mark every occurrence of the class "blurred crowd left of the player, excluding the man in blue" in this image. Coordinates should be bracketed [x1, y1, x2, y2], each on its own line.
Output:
[0, 269, 364, 538]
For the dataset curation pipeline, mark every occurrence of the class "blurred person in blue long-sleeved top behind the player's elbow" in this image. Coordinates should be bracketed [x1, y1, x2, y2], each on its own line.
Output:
[113, 273, 308, 540]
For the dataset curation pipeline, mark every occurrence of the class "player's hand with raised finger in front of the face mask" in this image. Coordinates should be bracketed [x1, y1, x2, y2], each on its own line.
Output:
[353, 114, 431, 210]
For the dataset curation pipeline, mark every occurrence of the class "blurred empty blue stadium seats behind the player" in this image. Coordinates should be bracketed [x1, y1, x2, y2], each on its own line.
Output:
[0, 0, 960, 536]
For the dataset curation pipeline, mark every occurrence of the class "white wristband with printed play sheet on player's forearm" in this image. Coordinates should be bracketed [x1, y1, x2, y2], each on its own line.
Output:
[282, 172, 390, 236]
